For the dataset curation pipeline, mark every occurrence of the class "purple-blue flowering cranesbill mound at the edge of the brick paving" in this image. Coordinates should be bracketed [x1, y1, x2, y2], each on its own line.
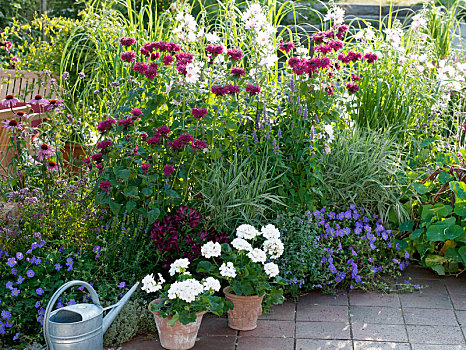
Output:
[312, 205, 409, 291]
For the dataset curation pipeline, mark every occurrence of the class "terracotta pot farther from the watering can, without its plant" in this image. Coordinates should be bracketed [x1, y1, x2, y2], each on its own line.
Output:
[223, 287, 264, 331]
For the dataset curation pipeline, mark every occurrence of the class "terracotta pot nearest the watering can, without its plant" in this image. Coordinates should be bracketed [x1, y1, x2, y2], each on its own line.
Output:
[149, 299, 206, 350]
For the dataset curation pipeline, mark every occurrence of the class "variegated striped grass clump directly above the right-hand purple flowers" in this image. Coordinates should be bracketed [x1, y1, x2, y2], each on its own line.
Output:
[321, 126, 407, 222]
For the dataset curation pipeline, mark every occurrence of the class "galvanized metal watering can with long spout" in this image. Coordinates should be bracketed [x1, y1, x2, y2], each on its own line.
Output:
[44, 281, 139, 350]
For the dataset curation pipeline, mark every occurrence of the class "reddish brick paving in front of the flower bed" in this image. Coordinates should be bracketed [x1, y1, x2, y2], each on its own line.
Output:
[122, 267, 466, 350]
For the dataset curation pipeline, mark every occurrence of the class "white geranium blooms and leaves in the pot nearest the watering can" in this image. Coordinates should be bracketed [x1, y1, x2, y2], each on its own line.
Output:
[142, 258, 232, 326]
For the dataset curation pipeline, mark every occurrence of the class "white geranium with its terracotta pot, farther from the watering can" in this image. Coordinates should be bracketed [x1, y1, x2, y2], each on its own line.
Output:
[197, 224, 284, 331]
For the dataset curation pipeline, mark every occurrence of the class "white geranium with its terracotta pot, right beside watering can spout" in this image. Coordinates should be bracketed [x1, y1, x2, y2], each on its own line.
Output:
[142, 258, 233, 350]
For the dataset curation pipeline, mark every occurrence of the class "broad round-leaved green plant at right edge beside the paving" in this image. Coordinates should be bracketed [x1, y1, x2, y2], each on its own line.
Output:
[400, 150, 466, 275]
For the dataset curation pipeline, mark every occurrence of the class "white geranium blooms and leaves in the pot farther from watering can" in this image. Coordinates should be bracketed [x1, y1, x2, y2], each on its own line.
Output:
[197, 224, 285, 304]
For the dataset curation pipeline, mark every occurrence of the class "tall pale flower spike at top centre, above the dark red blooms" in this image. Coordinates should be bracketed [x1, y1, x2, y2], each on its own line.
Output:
[242, 3, 278, 68]
